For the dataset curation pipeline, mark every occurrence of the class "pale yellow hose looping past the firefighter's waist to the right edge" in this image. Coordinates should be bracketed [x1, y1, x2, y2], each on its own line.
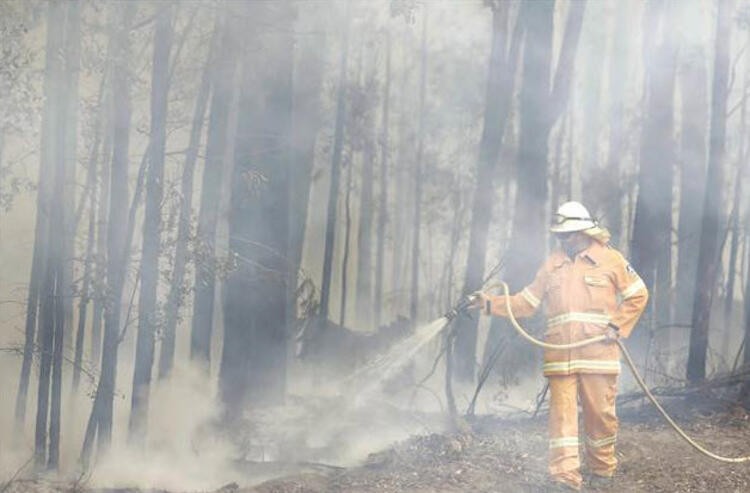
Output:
[500, 281, 750, 463]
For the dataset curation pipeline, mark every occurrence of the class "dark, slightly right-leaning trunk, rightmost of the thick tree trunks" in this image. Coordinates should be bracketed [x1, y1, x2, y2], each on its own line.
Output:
[687, 0, 734, 383]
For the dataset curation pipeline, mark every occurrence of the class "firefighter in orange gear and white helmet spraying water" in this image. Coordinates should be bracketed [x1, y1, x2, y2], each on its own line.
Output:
[477, 202, 648, 490]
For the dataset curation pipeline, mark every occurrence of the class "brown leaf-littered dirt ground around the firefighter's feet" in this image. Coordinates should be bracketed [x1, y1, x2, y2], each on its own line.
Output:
[0, 403, 750, 493]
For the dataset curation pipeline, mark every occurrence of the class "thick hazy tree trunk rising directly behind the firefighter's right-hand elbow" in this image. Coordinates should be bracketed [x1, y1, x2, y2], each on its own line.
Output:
[631, 0, 677, 350]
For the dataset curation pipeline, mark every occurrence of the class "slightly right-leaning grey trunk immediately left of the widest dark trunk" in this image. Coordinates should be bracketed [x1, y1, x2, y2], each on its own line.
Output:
[190, 3, 237, 372]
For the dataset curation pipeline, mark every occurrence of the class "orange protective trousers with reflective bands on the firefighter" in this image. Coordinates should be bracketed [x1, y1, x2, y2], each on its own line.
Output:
[548, 373, 617, 488]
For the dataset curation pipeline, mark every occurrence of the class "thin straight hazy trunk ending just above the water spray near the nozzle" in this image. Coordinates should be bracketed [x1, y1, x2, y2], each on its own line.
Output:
[409, 4, 427, 326]
